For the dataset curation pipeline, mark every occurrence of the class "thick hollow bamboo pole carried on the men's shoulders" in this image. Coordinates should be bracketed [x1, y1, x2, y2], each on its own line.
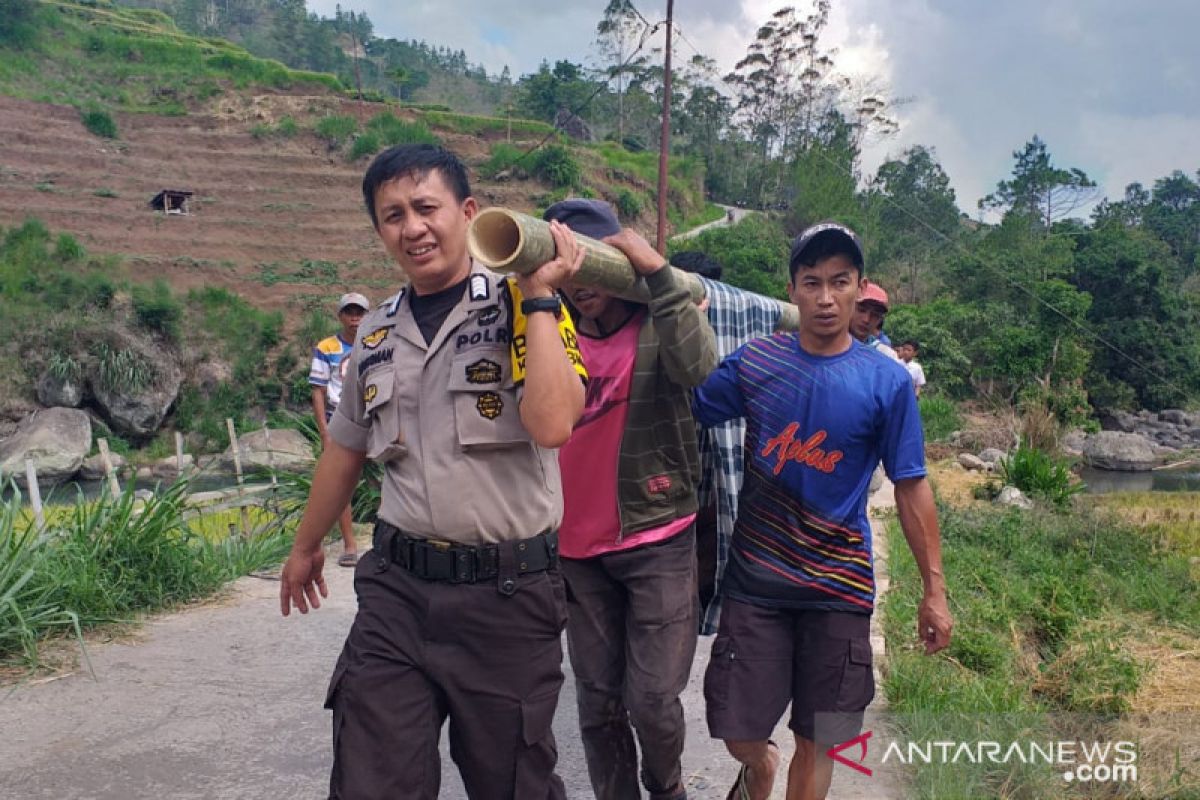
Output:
[467, 207, 800, 331]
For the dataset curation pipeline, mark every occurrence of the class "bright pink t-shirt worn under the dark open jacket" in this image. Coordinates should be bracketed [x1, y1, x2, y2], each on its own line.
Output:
[558, 311, 696, 559]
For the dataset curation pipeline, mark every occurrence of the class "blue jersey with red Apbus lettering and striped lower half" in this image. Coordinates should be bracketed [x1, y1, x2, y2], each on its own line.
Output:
[694, 332, 925, 614]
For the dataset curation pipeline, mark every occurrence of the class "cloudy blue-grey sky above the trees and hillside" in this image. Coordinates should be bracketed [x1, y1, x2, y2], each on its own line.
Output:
[308, 0, 1200, 215]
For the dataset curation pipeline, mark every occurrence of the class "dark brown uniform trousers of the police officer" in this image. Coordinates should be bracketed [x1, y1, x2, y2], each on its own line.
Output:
[325, 551, 566, 800]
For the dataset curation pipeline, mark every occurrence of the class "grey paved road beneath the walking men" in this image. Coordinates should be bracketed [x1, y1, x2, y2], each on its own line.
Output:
[0, 493, 894, 800]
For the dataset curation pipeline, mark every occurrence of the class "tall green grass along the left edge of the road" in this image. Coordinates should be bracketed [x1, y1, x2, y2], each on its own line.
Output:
[0, 481, 290, 664]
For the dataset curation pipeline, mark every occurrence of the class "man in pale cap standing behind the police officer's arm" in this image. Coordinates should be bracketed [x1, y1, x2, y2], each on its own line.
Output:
[308, 291, 371, 566]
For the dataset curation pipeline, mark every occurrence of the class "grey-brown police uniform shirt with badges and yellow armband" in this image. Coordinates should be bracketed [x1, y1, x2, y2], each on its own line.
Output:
[329, 263, 587, 545]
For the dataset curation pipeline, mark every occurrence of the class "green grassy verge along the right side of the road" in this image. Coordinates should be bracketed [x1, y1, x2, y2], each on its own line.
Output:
[882, 507, 1200, 798]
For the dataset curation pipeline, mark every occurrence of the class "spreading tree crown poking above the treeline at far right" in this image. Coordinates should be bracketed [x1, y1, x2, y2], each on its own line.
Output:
[979, 134, 1099, 228]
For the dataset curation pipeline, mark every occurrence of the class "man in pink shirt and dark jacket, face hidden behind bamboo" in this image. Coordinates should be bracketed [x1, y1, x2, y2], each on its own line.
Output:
[545, 200, 716, 800]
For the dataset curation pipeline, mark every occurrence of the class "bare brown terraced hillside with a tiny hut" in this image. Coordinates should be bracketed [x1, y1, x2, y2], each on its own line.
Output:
[0, 94, 549, 316]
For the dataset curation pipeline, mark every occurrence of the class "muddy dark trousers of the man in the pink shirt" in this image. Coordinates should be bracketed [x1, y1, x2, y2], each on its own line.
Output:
[562, 527, 698, 800]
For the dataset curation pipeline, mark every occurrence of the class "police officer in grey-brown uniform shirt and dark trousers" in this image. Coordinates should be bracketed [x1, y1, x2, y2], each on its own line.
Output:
[280, 145, 586, 800]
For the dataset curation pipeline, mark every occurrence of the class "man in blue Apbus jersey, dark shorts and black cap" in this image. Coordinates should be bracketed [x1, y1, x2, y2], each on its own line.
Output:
[695, 223, 952, 800]
